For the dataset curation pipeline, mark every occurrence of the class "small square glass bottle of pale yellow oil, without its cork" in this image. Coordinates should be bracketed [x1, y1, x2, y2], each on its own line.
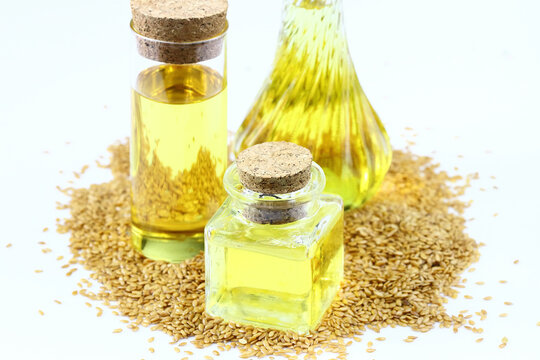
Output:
[205, 163, 343, 333]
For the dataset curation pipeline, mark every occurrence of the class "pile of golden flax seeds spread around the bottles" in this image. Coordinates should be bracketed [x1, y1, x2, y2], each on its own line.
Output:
[58, 143, 479, 359]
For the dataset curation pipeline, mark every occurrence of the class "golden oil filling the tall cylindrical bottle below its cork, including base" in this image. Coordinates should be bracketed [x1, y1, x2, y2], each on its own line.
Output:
[130, 64, 227, 262]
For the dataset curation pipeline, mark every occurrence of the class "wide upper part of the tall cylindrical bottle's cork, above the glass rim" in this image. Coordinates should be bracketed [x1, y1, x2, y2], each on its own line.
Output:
[131, 0, 228, 42]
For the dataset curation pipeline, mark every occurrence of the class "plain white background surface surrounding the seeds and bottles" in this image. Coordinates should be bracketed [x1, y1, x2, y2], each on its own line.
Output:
[0, 0, 540, 360]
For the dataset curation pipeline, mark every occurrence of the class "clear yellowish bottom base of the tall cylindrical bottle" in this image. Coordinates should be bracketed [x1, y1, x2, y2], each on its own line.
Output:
[131, 225, 204, 263]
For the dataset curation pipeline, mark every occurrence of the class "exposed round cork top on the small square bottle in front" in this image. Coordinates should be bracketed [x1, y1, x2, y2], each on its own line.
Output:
[236, 141, 313, 194]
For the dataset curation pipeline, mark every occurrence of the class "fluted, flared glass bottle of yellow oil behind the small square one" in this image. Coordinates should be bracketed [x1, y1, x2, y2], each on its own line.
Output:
[234, 0, 391, 209]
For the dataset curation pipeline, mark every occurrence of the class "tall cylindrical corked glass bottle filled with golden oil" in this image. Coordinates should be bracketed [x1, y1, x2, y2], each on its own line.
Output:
[130, 0, 227, 262]
